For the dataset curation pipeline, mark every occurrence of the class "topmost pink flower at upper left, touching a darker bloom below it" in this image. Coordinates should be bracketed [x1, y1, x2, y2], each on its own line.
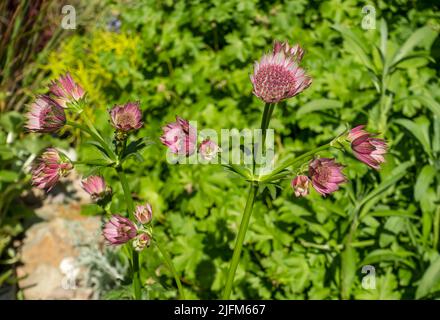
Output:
[50, 72, 85, 108]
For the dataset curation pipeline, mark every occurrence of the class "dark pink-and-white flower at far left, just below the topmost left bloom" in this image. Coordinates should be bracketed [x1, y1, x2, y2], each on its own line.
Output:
[25, 95, 66, 133]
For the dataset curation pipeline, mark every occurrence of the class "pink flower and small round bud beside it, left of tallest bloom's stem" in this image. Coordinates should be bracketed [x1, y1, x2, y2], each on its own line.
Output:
[160, 116, 221, 161]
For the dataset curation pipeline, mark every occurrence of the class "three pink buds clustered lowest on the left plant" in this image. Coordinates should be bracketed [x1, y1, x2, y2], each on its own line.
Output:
[102, 203, 153, 251]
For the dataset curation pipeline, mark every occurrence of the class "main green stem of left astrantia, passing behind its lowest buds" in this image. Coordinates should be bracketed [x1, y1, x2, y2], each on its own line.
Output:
[116, 166, 141, 300]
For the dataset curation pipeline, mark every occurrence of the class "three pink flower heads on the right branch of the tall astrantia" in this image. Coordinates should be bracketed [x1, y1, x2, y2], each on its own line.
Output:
[291, 125, 387, 197]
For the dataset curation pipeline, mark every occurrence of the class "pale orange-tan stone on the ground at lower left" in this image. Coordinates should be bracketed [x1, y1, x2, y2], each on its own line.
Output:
[16, 170, 102, 300]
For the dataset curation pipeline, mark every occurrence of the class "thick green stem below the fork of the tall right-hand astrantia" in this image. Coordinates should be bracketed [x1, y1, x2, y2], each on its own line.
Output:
[223, 183, 258, 300]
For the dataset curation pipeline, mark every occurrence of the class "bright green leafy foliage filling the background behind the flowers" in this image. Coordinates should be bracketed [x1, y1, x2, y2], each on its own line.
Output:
[2, 0, 440, 299]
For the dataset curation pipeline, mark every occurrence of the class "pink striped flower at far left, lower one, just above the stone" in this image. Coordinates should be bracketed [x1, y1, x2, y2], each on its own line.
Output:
[32, 148, 73, 192]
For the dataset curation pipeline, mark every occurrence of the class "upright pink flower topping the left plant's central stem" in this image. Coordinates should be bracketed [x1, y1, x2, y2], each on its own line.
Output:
[110, 102, 143, 132]
